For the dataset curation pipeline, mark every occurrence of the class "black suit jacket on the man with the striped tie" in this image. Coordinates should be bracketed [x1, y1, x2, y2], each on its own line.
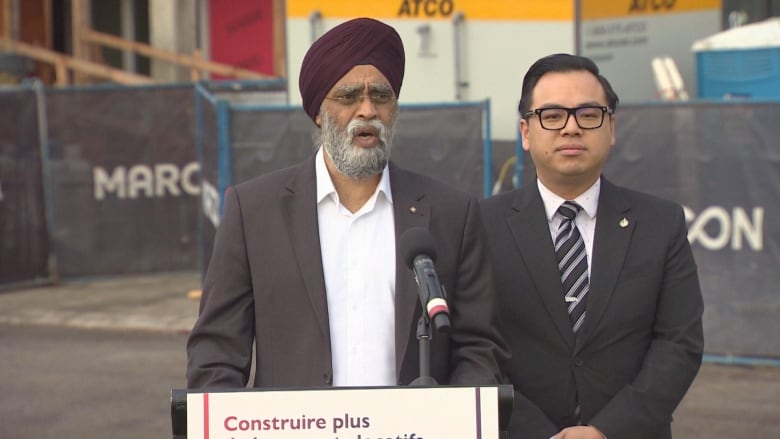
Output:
[482, 178, 703, 439]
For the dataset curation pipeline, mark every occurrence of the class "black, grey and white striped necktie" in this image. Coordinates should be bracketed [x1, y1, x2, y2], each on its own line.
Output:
[555, 201, 588, 334]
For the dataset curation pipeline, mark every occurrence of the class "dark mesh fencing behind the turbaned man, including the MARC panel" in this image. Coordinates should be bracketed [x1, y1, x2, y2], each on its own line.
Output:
[0, 81, 490, 288]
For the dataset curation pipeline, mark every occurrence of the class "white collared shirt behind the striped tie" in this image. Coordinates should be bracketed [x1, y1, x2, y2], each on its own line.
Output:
[536, 178, 601, 277]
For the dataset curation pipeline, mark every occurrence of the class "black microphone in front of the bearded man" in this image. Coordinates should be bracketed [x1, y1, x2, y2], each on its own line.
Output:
[398, 227, 450, 332]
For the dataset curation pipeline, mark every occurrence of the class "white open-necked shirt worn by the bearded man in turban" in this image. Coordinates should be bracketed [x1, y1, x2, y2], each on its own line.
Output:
[315, 147, 397, 386]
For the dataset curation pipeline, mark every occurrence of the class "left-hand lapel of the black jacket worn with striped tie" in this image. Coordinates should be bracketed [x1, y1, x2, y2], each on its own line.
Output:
[507, 185, 574, 347]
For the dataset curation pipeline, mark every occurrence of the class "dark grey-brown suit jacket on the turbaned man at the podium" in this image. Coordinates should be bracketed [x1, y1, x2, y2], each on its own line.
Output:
[187, 156, 508, 388]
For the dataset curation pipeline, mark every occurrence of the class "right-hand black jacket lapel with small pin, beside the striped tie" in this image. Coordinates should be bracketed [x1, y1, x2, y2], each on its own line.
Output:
[578, 177, 637, 345]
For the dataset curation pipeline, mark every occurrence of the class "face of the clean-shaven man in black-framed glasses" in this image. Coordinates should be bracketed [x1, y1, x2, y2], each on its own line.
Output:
[520, 71, 615, 190]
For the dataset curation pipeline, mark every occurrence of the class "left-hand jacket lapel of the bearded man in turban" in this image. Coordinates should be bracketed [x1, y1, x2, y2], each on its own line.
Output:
[281, 155, 330, 342]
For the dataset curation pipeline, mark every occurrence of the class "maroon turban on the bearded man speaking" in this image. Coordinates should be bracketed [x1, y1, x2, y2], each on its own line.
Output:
[298, 18, 405, 120]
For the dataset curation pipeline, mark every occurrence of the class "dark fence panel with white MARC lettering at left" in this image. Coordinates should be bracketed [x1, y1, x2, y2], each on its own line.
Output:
[46, 86, 200, 277]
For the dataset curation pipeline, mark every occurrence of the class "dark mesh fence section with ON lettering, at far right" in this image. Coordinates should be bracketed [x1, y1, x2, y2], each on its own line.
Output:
[605, 102, 780, 357]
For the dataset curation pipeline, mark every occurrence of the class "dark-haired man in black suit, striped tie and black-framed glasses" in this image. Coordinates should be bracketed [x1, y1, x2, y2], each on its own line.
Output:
[482, 54, 703, 439]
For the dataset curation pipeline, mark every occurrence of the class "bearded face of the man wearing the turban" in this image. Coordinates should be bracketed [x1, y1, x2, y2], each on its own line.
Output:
[316, 65, 398, 178]
